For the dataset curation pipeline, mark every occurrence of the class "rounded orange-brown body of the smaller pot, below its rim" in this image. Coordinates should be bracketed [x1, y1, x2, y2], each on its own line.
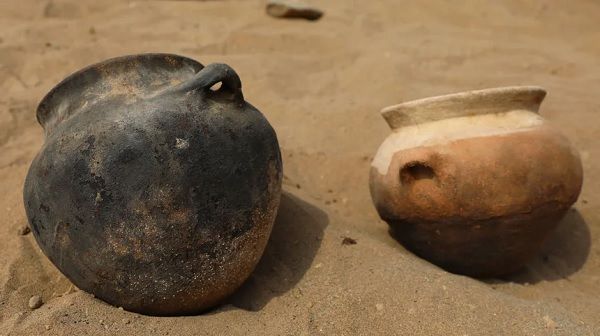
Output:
[370, 125, 582, 277]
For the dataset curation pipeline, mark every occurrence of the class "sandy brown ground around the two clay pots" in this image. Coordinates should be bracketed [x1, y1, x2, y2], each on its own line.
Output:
[0, 0, 600, 335]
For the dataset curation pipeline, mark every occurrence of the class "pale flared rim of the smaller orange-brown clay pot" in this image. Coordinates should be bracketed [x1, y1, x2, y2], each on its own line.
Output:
[381, 86, 546, 129]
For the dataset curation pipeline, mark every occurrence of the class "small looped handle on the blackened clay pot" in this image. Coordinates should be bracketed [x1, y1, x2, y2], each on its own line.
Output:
[177, 63, 244, 100]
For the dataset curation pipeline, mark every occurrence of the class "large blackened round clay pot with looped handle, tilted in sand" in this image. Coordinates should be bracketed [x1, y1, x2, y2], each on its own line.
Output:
[24, 54, 282, 315]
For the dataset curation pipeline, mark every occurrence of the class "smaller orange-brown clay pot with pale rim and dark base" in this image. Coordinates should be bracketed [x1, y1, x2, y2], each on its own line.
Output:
[370, 87, 583, 277]
